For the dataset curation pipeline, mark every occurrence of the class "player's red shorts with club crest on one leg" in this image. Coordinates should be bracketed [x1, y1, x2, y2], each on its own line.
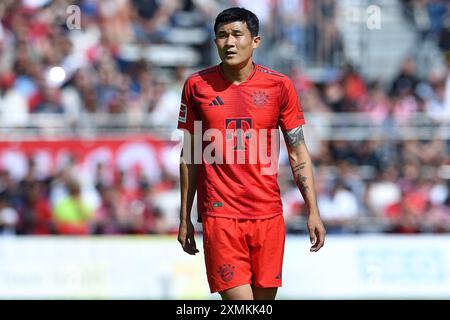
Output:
[202, 214, 286, 293]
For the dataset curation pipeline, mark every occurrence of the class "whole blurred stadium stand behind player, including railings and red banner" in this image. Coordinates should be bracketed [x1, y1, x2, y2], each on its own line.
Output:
[0, 0, 450, 235]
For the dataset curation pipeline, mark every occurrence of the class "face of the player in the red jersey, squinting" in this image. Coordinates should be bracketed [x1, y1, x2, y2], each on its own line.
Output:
[215, 21, 261, 67]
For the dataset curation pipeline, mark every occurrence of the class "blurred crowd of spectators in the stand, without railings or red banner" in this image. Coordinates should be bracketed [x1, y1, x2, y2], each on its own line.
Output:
[0, 0, 450, 235]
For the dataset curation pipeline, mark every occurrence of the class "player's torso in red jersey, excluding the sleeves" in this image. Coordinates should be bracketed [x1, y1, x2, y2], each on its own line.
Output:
[189, 67, 283, 219]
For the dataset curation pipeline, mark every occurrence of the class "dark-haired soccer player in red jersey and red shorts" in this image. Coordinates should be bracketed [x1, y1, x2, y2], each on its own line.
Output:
[178, 8, 325, 300]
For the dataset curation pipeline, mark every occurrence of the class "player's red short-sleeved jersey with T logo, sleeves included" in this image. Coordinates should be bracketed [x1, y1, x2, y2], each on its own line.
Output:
[178, 64, 305, 221]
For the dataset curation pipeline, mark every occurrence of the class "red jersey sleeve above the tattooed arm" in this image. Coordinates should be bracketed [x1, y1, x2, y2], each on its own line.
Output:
[278, 79, 305, 131]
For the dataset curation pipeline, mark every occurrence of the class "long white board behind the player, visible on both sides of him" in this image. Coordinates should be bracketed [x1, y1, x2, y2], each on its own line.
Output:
[0, 235, 450, 299]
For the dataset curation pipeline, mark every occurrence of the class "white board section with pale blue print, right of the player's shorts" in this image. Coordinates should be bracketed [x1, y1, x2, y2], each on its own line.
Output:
[279, 235, 450, 299]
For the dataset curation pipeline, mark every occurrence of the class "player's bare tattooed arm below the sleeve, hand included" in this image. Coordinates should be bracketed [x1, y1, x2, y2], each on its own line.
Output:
[283, 126, 326, 252]
